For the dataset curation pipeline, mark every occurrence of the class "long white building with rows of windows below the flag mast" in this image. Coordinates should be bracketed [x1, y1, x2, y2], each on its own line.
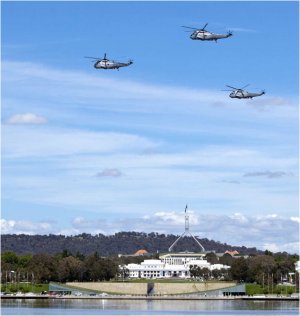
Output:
[124, 253, 230, 279]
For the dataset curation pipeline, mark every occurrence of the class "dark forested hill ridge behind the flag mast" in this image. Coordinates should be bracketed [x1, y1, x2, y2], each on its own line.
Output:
[1, 232, 262, 256]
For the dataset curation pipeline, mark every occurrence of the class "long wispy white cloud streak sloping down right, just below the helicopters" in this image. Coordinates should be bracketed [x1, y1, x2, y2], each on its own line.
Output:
[2, 61, 297, 121]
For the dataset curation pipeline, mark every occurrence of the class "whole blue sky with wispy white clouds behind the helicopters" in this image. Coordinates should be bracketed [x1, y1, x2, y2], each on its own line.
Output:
[1, 1, 299, 251]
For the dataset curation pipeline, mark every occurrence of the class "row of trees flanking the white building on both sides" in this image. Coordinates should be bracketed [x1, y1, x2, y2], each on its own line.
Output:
[1, 250, 299, 286]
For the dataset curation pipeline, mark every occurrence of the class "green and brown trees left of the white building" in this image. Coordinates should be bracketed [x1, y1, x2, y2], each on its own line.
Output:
[1, 250, 151, 284]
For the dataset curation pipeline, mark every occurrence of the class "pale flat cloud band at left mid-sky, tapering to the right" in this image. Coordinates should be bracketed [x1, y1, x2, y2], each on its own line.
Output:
[3, 126, 157, 158]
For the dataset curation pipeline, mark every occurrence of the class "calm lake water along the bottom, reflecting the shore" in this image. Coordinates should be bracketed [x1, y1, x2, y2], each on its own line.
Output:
[1, 299, 299, 316]
